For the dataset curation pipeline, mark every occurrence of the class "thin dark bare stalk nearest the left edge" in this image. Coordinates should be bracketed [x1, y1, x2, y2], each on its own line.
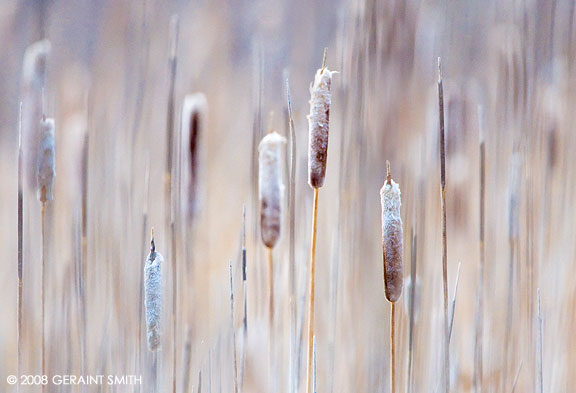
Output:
[16, 102, 24, 392]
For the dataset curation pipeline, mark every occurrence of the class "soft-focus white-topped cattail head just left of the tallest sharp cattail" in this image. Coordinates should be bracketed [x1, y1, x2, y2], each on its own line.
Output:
[258, 132, 286, 248]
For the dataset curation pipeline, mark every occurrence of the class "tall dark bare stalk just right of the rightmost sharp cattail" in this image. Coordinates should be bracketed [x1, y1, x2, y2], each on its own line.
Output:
[438, 58, 450, 393]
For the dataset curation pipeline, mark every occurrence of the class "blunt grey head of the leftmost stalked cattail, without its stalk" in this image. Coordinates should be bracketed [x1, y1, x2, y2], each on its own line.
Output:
[36, 119, 56, 202]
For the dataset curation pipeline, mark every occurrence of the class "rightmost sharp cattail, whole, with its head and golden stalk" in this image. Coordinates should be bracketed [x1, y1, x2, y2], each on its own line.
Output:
[380, 161, 404, 393]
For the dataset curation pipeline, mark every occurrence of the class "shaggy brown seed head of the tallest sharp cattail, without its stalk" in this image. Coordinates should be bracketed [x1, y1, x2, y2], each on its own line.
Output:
[308, 67, 335, 188]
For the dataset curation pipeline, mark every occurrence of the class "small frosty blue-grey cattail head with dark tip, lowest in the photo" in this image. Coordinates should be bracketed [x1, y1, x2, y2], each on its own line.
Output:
[144, 231, 164, 352]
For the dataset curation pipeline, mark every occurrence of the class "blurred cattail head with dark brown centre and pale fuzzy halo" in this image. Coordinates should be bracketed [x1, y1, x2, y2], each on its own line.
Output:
[181, 93, 207, 218]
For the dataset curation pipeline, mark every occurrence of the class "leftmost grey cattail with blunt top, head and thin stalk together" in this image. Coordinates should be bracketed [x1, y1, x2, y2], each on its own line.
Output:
[36, 117, 56, 391]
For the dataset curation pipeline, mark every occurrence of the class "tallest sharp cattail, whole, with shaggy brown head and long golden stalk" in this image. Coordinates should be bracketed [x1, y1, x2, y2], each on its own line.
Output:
[306, 49, 334, 393]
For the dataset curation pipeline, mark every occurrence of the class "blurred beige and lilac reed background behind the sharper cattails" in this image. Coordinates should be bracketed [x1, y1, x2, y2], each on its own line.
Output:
[0, 0, 576, 393]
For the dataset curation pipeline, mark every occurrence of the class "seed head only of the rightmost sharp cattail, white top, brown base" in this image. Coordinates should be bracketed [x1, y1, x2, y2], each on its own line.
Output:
[380, 164, 404, 303]
